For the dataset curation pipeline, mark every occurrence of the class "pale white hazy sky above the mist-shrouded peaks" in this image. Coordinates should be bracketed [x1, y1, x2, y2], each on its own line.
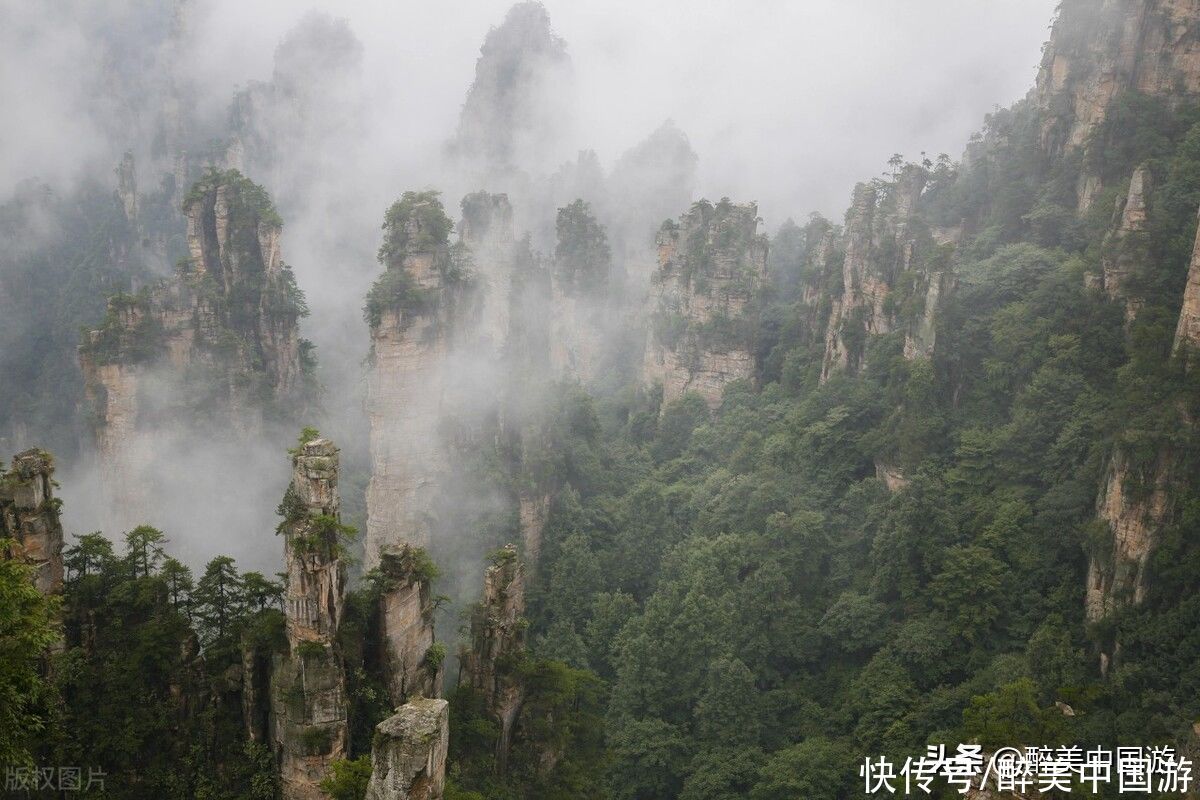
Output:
[192, 0, 1056, 225]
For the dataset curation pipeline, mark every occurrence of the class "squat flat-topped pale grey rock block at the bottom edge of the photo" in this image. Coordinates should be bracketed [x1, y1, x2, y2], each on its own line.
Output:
[366, 698, 450, 800]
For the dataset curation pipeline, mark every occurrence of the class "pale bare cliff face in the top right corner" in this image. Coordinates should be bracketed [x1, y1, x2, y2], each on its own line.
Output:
[1033, 0, 1200, 211]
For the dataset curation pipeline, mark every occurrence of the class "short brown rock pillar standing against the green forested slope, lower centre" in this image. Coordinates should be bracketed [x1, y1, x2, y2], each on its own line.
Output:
[462, 545, 526, 772]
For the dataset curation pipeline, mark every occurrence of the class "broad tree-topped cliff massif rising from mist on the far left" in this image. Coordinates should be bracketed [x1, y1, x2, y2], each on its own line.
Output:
[79, 172, 306, 521]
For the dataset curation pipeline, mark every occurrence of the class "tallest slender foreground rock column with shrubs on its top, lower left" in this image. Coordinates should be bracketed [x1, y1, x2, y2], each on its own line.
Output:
[270, 439, 348, 800]
